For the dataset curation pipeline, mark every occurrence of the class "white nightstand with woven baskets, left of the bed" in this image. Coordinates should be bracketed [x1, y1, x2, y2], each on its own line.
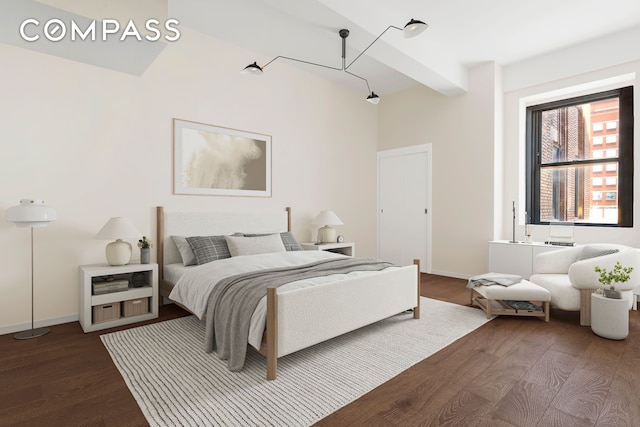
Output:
[78, 264, 158, 332]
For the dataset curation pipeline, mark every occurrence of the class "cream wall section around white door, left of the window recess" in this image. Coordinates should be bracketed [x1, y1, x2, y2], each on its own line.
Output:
[378, 63, 502, 277]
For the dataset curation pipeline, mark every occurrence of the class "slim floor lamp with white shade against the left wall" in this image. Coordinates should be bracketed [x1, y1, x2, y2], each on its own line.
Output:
[5, 199, 56, 340]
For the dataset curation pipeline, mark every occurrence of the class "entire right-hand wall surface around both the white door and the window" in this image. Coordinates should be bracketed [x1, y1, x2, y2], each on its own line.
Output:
[378, 61, 640, 278]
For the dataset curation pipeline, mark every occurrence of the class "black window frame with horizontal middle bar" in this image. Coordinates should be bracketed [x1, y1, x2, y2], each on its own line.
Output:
[525, 86, 634, 227]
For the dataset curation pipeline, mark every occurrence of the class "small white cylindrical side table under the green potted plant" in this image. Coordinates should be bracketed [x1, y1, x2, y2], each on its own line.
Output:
[591, 293, 629, 340]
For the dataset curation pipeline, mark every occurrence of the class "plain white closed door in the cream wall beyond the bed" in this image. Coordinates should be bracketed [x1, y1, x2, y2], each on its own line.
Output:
[378, 144, 431, 272]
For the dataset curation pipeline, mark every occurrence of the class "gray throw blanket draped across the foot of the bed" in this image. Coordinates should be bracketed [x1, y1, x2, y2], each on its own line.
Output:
[205, 257, 393, 371]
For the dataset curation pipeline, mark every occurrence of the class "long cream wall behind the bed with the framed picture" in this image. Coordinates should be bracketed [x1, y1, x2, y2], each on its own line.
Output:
[0, 28, 377, 333]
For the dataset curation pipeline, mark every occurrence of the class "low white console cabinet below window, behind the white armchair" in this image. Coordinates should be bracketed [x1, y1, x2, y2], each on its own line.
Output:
[489, 240, 566, 279]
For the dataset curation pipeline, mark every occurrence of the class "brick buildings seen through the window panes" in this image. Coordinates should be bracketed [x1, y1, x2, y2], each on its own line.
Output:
[540, 98, 618, 223]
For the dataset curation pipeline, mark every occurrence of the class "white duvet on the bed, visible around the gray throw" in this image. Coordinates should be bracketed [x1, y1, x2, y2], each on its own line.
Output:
[165, 251, 398, 348]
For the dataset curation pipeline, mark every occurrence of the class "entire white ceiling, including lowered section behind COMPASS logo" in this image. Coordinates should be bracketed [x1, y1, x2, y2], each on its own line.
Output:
[0, 0, 640, 96]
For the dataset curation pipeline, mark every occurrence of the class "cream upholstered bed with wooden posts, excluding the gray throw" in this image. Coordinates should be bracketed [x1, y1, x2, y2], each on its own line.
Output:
[156, 206, 420, 380]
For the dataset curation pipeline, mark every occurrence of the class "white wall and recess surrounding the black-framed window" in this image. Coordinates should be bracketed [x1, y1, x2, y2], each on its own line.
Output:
[496, 61, 640, 247]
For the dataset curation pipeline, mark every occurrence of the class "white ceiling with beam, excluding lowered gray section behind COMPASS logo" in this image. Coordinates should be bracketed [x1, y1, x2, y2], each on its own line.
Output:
[169, 0, 640, 96]
